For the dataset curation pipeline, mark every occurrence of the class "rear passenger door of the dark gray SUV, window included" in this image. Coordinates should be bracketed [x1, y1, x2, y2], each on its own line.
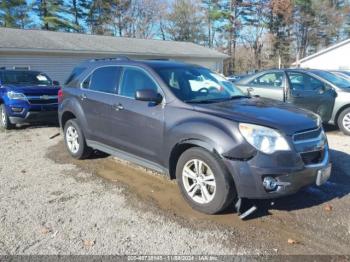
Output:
[79, 66, 122, 145]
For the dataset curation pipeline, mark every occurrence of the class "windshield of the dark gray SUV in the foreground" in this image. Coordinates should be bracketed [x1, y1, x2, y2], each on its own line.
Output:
[155, 66, 246, 103]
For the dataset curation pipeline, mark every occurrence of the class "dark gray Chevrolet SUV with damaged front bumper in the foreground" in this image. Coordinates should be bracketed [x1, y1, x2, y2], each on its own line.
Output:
[59, 58, 331, 214]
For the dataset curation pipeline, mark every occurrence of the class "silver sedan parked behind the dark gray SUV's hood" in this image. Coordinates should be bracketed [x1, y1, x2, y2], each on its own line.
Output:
[236, 69, 350, 135]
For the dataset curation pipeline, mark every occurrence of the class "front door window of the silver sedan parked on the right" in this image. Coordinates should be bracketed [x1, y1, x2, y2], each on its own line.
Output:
[287, 72, 325, 91]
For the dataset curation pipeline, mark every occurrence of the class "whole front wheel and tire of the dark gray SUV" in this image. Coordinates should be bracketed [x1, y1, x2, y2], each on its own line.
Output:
[176, 147, 236, 214]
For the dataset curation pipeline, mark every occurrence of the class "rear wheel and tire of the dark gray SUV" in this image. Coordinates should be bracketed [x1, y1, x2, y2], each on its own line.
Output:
[64, 119, 92, 159]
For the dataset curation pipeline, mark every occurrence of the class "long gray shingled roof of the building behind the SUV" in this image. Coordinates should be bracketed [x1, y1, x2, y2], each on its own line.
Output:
[0, 27, 228, 59]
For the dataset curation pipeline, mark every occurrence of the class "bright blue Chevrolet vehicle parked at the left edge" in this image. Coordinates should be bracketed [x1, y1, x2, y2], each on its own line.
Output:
[0, 69, 59, 129]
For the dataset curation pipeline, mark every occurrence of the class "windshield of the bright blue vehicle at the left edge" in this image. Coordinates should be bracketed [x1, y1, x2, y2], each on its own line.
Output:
[1, 70, 52, 86]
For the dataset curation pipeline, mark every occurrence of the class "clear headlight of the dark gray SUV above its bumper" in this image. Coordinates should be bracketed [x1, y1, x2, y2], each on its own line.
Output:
[239, 123, 290, 154]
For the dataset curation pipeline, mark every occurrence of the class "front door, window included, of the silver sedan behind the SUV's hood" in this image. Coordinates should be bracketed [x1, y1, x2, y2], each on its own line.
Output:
[287, 71, 335, 122]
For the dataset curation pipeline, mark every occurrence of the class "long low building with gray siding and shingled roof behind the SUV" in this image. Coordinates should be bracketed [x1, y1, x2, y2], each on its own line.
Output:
[0, 28, 227, 82]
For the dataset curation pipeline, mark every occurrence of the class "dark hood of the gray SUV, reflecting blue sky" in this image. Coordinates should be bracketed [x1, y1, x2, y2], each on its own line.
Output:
[194, 98, 319, 135]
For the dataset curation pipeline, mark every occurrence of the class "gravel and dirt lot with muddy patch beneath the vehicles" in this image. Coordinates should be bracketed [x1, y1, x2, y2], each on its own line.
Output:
[0, 127, 350, 255]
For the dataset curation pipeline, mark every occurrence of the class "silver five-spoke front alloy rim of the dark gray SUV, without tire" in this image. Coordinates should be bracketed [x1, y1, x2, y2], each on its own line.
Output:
[182, 159, 216, 204]
